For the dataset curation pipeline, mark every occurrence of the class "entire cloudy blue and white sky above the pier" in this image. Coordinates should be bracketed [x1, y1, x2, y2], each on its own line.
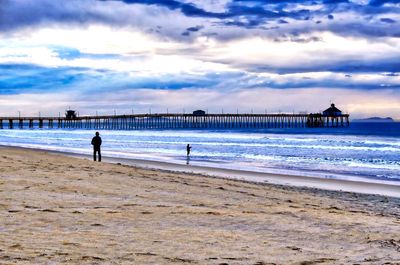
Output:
[0, 0, 400, 119]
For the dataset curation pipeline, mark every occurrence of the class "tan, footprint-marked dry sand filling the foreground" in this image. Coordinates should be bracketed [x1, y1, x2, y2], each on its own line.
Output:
[0, 147, 400, 264]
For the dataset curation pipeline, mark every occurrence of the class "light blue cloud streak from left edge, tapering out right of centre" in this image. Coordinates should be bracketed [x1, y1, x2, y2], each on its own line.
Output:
[0, 61, 243, 97]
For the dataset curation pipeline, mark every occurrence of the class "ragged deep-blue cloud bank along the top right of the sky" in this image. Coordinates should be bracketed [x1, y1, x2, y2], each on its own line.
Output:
[101, 0, 400, 39]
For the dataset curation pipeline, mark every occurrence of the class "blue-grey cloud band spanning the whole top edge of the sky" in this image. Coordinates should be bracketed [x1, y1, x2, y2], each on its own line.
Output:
[0, 0, 400, 40]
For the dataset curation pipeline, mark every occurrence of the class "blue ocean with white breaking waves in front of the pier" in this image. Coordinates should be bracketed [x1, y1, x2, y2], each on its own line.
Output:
[0, 123, 400, 185]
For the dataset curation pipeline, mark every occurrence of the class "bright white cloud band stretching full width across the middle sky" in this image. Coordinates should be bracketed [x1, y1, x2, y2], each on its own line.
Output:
[0, 21, 400, 76]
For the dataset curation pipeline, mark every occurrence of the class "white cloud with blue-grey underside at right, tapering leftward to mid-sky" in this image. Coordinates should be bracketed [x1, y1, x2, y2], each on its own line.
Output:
[198, 33, 400, 74]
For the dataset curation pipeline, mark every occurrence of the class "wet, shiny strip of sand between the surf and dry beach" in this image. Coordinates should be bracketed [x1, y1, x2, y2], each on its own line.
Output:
[0, 145, 400, 198]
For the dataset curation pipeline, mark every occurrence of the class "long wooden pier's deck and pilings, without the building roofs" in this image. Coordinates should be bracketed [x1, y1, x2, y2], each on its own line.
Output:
[0, 113, 349, 130]
